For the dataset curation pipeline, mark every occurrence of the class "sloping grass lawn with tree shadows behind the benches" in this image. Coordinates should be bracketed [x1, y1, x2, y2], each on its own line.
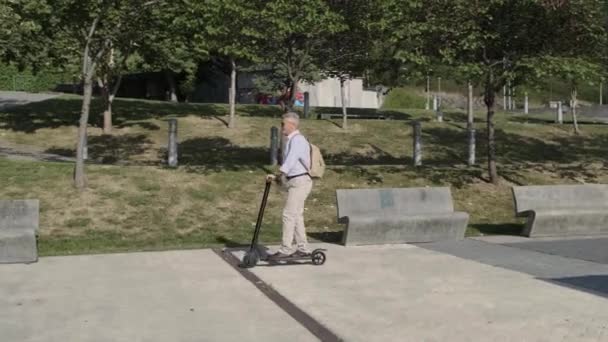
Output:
[0, 97, 608, 255]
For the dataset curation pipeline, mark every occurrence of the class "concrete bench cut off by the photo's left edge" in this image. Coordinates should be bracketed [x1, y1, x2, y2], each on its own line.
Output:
[0, 200, 39, 263]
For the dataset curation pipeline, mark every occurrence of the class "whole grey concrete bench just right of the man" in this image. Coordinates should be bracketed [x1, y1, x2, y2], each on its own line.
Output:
[337, 188, 469, 245]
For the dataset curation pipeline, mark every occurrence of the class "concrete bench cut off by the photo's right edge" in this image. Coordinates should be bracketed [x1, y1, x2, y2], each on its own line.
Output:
[513, 184, 608, 237]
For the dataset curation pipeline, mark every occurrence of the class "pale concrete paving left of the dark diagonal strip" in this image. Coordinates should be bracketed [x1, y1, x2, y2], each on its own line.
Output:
[0, 250, 316, 342]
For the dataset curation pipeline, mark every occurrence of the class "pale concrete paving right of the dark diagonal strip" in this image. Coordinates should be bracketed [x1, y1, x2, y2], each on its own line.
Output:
[238, 245, 608, 341]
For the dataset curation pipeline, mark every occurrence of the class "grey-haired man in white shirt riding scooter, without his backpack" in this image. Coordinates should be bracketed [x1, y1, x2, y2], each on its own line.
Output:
[268, 112, 312, 260]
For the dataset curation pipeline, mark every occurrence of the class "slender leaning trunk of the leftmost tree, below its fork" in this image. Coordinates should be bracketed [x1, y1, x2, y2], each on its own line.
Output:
[74, 71, 93, 191]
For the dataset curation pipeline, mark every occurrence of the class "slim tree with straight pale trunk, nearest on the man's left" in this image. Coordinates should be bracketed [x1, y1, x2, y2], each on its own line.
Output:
[202, 0, 264, 128]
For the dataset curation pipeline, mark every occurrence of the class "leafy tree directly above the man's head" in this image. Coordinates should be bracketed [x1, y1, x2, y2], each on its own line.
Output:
[259, 0, 344, 108]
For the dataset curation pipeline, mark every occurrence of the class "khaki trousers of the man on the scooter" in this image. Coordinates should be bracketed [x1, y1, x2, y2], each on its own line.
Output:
[279, 176, 312, 254]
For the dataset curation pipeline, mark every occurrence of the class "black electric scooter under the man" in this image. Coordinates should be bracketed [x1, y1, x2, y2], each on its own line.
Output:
[239, 179, 327, 268]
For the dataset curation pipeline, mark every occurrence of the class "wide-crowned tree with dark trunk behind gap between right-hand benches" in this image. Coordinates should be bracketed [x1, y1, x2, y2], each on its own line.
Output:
[380, 0, 606, 184]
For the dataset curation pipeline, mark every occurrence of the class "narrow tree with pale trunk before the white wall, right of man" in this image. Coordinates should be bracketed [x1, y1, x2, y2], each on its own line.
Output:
[324, 0, 373, 130]
